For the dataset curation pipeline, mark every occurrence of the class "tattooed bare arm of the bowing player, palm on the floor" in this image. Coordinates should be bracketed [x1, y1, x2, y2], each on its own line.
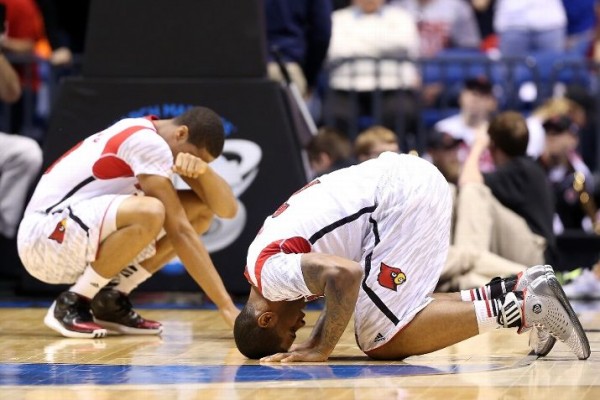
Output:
[264, 253, 363, 362]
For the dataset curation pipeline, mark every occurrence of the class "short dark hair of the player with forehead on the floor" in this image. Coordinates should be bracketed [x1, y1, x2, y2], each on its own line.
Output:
[233, 303, 287, 360]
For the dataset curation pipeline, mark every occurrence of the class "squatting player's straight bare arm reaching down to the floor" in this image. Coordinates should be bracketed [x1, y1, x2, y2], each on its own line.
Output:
[138, 175, 238, 325]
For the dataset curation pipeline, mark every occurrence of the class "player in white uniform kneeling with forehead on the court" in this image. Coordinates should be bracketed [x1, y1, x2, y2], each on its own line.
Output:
[234, 153, 590, 362]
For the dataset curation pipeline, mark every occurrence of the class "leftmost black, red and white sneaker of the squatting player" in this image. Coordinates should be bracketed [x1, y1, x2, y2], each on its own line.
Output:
[44, 291, 107, 339]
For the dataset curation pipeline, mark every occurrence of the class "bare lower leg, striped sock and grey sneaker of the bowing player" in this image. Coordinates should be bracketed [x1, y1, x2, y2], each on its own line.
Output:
[366, 266, 590, 360]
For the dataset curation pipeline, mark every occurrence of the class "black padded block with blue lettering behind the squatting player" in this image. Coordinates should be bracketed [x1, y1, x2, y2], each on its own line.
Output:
[24, 78, 306, 295]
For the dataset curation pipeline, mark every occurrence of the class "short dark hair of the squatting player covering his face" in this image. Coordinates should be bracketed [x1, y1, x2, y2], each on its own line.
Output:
[173, 106, 225, 158]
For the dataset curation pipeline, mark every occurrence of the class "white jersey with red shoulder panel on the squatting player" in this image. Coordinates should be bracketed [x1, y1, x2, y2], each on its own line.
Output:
[25, 117, 173, 215]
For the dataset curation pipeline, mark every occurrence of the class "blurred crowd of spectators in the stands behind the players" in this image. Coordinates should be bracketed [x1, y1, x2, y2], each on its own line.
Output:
[0, 0, 600, 293]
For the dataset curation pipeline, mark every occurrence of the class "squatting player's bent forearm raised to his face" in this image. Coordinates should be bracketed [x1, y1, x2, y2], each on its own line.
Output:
[182, 167, 237, 218]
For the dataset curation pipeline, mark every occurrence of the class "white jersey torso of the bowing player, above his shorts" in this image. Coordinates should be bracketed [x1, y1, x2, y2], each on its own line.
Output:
[247, 154, 383, 285]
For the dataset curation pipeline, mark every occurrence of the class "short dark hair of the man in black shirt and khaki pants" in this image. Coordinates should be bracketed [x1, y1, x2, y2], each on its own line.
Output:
[488, 111, 529, 157]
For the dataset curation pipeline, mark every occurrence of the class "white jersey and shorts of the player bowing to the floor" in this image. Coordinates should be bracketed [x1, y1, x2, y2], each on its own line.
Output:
[246, 152, 452, 351]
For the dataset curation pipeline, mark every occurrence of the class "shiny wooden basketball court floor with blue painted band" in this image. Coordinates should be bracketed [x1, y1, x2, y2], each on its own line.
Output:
[0, 302, 600, 400]
